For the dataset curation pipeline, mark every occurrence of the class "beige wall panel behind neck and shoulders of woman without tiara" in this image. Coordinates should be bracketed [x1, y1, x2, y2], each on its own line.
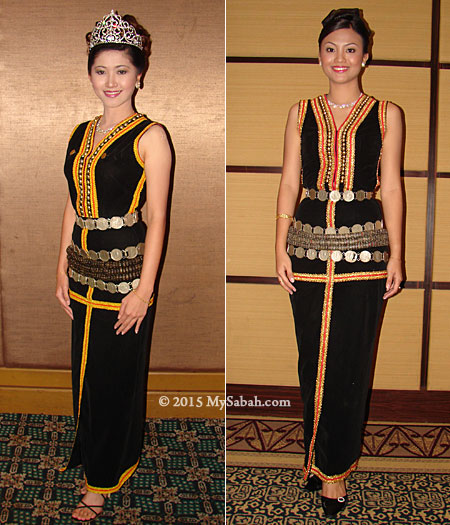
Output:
[227, 64, 429, 170]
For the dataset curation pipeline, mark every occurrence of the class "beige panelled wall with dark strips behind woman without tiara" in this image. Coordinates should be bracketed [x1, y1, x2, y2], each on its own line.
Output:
[227, 0, 450, 390]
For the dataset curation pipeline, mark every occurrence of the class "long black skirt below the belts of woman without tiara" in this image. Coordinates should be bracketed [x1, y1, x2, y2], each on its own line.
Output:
[291, 274, 386, 482]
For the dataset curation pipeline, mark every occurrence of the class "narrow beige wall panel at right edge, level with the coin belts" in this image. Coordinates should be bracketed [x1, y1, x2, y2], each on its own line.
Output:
[433, 179, 450, 280]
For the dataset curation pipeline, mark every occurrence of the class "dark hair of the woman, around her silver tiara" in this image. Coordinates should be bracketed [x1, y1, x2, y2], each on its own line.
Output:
[86, 15, 152, 73]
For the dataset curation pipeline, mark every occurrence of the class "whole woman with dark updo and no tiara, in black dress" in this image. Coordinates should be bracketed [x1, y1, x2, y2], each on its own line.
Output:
[276, 9, 403, 517]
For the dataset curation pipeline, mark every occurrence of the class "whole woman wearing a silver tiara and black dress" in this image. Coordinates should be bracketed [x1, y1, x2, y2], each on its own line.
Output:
[56, 11, 172, 521]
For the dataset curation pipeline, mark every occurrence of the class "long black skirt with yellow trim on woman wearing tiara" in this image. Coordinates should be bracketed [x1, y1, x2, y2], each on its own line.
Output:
[63, 281, 154, 493]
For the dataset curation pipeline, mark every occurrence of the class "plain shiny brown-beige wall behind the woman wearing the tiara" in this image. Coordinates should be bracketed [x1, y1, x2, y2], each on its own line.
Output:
[0, 0, 225, 378]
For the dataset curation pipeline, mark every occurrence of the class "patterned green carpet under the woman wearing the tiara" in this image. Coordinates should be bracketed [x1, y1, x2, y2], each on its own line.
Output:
[0, 414, 225, 525]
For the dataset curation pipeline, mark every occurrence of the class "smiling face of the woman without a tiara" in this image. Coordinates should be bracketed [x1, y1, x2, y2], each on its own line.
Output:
[319, 28, 369, 84]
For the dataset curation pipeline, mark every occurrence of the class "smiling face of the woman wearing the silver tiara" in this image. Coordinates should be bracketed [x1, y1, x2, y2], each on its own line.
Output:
[89, 49, 141, 108]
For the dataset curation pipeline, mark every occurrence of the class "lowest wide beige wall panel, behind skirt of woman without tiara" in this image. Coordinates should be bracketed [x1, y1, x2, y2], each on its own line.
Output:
[227, 284, 423, 390]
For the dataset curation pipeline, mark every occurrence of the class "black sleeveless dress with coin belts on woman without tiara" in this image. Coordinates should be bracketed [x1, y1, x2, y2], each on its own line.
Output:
[288, 94, 388, 482]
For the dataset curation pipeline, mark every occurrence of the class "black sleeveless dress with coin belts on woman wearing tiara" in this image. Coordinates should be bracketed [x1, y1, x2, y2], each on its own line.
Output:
[62, 113, 155, 493]
